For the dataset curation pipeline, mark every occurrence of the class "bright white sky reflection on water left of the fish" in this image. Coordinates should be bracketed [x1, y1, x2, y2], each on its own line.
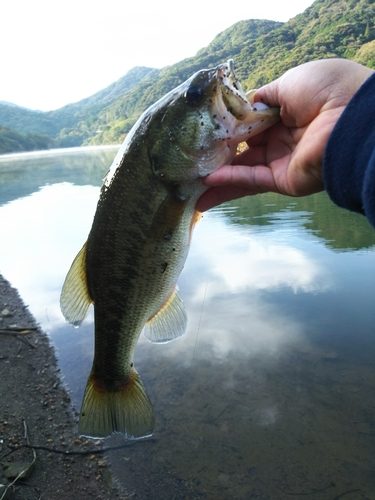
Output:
[0, 183, 99, 330]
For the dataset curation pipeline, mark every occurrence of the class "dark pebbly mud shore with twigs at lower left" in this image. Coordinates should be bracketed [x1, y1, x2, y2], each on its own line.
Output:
[0, 275, 121, 500]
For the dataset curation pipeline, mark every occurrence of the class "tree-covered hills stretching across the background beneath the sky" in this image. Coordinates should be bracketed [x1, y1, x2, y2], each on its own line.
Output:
[0, 0, 375, 152]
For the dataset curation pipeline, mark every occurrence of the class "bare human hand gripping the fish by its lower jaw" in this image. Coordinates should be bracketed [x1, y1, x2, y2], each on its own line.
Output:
[196, 59, 373, 212]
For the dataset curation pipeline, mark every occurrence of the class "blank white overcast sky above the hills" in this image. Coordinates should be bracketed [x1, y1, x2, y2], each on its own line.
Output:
[0, 0, 313, 111]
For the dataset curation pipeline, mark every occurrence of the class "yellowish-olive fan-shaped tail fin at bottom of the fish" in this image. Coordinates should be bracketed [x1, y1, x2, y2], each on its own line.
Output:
[78, 370, 154, 439]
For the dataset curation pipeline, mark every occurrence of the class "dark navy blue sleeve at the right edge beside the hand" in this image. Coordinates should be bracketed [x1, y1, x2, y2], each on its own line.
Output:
[323, 73, 375, 227]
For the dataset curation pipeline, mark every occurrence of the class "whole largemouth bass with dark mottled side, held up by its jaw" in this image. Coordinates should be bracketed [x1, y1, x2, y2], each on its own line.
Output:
[60, 59, 279, 439]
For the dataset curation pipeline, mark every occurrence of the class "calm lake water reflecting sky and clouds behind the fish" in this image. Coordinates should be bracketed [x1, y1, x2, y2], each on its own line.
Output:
[0, 148, 375, 500]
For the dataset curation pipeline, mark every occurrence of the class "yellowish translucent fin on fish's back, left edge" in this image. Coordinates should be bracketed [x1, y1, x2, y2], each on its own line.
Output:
[60, 243, 92, 327]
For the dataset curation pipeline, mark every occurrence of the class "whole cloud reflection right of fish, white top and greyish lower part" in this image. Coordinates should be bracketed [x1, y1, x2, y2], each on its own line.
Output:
[137, 210, 332, 366]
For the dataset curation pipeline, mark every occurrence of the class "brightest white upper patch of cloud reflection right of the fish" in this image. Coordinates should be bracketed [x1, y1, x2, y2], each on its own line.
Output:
[192, 220, 327, 293]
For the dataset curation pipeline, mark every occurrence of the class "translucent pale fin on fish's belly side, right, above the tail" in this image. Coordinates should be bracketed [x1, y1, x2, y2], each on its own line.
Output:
[144, 287, 187, 344]
